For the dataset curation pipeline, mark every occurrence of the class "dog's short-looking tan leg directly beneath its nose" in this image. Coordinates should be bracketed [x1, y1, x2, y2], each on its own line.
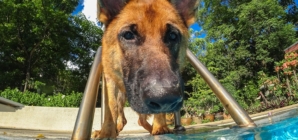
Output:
[151, 113, 173, 135]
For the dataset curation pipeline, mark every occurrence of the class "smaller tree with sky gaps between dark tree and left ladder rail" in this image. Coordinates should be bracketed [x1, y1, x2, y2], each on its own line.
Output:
[57, 14, 103, 93]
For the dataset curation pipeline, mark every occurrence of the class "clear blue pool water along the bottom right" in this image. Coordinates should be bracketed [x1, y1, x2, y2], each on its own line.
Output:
[121, 110, 298, 140]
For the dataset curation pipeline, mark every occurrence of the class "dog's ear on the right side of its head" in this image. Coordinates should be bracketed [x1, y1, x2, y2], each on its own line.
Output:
[170, 0, 199, 27]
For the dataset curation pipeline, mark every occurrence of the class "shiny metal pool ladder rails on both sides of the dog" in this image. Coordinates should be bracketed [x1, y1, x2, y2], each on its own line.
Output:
[71, 47, 256, 140]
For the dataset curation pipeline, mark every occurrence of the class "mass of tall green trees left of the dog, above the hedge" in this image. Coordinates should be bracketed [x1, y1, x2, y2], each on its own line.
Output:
[0, 0, 102, 94]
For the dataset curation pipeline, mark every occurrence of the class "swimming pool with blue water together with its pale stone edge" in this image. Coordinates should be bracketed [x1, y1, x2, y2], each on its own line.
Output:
[0, 105, 298, 140]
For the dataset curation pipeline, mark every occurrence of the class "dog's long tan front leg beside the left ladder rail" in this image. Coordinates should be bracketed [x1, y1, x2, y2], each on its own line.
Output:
[92, 75, 118, 138]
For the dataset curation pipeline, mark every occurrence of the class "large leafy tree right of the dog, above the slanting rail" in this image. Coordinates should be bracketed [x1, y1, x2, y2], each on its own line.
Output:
[189, 0, 297, 109]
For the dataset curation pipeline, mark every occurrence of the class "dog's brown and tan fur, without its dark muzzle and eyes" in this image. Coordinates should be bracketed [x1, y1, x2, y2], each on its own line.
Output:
[92, 0, 198, 138]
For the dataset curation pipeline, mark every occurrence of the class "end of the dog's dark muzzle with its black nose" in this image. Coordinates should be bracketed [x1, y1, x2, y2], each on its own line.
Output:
[126, 77, 183, 114]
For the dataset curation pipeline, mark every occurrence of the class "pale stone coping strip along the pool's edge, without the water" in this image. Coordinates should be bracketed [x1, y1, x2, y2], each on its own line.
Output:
[0, 104, 298, 139]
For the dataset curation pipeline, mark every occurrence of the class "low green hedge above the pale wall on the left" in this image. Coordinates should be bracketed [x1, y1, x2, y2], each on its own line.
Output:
[0, 88, 83, 107]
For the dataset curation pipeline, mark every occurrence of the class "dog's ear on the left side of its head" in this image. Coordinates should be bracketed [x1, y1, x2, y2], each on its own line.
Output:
[97, 0, 127, 25]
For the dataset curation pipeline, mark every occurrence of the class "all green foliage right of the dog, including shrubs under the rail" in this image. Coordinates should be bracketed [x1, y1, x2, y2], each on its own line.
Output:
[186, 0, 298, 115]
